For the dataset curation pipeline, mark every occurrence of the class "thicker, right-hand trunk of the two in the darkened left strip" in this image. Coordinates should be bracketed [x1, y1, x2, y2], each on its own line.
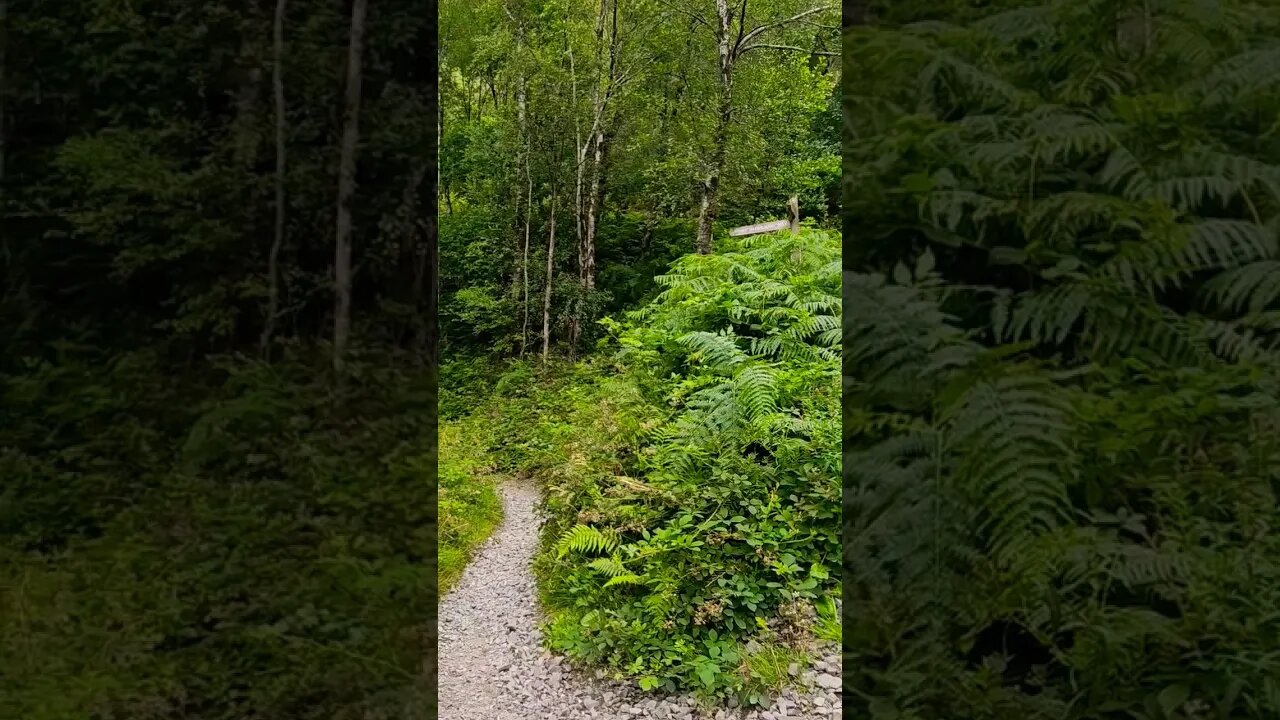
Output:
[333, 0, 369, 378]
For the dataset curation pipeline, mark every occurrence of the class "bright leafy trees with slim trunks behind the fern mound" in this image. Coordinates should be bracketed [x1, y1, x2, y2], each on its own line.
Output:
[439, 0, 840, 357]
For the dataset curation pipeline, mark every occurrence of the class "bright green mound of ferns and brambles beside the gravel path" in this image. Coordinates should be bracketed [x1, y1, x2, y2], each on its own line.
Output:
[513, 231, 841, 702]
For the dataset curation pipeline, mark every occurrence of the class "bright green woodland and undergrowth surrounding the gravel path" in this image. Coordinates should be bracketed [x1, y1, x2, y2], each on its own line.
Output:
[439, 0, 841, 719]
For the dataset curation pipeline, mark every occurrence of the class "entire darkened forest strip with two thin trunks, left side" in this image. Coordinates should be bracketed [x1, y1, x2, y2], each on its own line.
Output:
[0, 0, 439, 720]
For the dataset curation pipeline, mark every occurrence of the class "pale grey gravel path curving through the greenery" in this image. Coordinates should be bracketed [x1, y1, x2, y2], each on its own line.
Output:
[439, 480, 840, 720]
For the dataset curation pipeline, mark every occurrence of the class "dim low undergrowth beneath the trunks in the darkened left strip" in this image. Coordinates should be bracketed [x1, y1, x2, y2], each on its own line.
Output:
[0, 348, 435, 720]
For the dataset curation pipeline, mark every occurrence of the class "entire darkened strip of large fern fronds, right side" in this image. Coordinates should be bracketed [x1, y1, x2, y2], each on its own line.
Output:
[842, 0, 1280, 720]
